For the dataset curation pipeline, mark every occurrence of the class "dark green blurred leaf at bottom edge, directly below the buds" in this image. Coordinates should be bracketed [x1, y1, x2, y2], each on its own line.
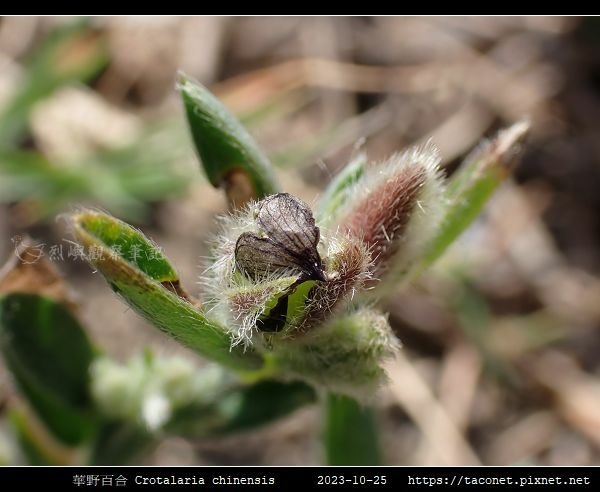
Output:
[324, 393, 381, 466]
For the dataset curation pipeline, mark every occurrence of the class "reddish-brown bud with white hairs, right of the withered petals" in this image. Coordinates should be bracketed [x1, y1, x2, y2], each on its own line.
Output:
[338, 144, 443, 288]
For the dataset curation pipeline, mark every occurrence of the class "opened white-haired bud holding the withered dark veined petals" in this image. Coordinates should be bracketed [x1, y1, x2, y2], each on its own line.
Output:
[202, 193, 370, 345]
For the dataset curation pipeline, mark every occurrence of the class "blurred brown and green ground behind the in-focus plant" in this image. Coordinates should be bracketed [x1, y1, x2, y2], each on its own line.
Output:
[0, 17, 600, 465]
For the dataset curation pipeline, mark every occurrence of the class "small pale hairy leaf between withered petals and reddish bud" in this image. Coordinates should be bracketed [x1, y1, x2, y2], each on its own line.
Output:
[316, 153, 367, 226]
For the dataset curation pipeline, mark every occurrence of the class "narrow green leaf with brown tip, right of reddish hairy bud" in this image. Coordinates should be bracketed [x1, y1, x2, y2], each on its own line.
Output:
[409, 122, 529, 278]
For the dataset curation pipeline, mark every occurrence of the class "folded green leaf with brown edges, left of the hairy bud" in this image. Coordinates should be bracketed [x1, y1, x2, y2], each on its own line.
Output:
[71, 210, 263, 370]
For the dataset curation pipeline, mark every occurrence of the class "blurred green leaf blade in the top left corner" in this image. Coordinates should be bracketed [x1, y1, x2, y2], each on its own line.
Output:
[0, 19, 108, 147]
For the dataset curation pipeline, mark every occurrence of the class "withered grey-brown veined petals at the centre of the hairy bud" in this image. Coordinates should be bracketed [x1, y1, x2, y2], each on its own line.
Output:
[235, 193, 326, 332]
